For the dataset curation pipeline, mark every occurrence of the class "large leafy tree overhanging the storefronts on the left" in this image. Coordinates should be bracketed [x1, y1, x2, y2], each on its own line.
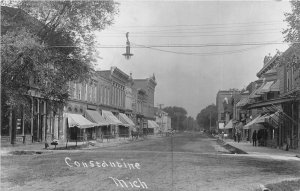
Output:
[1, 0, 118, 109]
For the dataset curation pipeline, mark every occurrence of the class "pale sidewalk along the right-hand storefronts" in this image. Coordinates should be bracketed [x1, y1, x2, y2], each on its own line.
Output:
[223, 139, 300, 158]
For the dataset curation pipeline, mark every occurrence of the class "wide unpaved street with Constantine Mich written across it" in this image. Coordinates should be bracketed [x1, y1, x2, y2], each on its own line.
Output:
[1, 133, 300, 191]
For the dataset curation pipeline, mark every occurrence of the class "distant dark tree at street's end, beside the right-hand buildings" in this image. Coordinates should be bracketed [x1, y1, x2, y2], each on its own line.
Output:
[197, 104, 218, 130]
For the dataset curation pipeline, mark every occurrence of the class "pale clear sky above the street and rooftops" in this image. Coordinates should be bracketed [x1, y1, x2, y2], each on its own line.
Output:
[96, 1, 291, 117]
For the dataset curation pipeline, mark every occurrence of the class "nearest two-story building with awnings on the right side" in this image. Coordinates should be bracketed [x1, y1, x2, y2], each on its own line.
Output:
[244, 45, 300, 149]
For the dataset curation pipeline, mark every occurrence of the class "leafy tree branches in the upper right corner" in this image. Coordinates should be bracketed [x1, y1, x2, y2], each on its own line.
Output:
[283, 1, 300, 43]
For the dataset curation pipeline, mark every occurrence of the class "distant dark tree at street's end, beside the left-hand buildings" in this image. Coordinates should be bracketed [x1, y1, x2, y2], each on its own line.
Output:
[163, 106, 187, 131]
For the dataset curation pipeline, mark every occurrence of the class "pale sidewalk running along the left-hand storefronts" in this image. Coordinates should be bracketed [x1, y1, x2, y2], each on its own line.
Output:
[1, 135, 161, 156]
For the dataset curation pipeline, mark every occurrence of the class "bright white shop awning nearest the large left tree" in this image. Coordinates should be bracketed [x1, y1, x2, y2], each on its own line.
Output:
[67, 113, 97, 129]
